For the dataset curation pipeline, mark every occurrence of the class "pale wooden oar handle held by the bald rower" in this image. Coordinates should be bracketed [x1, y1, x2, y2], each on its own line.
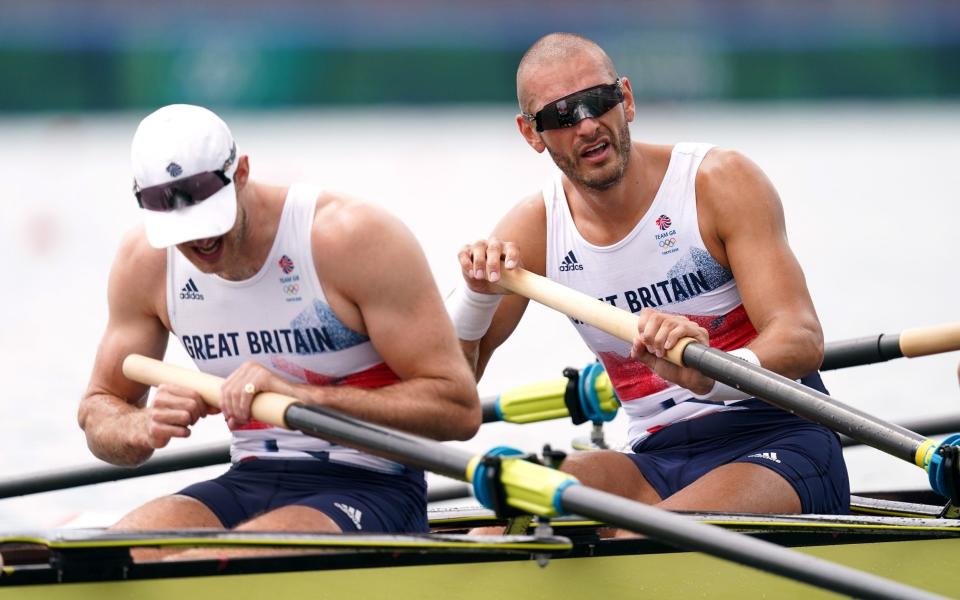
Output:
[498, 269, 696, 367]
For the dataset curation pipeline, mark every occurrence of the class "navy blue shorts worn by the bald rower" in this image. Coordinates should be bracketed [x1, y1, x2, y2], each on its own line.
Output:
[626, 374, 850, 514]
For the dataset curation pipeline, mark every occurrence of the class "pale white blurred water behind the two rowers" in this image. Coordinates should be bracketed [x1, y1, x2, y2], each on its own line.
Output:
[0, 105, 960, 527]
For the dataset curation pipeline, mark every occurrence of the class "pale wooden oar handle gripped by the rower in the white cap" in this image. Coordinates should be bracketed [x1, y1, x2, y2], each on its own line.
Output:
[123, 354, 298, 429]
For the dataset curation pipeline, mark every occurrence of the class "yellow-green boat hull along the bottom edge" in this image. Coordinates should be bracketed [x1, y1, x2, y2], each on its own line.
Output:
[0, 525, 960, 600]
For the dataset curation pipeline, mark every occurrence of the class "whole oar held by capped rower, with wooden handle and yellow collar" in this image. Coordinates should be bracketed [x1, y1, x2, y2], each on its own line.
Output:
[123, 355, 940, 599]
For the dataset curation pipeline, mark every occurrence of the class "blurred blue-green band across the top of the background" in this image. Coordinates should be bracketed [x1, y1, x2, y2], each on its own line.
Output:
[0, 0, 960, 112]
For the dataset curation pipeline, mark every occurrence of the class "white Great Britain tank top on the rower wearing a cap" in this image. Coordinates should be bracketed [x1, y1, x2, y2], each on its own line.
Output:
[167, 186, 405, 473]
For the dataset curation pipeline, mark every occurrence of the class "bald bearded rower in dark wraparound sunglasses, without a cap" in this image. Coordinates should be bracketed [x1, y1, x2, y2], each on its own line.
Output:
[447, 33, 849, 513]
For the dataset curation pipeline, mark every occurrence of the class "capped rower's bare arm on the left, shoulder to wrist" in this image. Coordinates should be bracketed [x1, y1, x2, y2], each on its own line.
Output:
[78, 229, 168, 465]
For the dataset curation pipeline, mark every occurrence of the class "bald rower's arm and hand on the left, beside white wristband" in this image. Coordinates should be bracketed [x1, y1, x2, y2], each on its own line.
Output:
[460, 193, 547, 381]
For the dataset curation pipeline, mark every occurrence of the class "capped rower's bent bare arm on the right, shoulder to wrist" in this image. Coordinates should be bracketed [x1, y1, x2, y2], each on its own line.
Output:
[266, 200, 480, 440]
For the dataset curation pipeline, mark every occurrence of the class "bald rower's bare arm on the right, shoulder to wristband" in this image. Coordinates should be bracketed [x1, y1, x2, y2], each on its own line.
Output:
[697, 149, 823, 378]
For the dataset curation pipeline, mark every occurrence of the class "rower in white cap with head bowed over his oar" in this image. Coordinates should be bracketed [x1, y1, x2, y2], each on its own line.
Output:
[79, 105, 480, 548]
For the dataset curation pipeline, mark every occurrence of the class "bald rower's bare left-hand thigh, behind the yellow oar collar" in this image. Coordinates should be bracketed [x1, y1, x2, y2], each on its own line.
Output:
[560, 450, 660, 504]
